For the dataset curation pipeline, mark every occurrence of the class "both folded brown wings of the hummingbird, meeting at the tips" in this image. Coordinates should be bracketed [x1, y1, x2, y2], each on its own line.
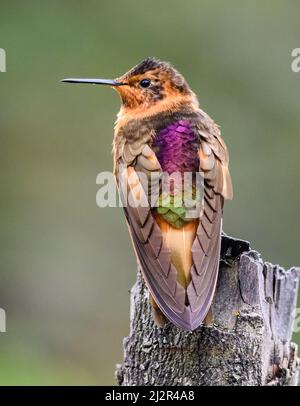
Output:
[116, 118, 232, 330]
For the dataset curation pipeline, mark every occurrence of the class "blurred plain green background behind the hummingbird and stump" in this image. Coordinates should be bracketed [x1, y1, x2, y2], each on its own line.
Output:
[0, 0, 300, 385]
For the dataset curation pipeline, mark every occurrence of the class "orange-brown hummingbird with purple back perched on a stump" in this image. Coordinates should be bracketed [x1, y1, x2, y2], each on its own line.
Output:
[62, 57, 233, 331]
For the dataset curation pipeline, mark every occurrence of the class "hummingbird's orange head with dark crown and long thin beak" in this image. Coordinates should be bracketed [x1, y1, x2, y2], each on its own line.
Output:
[63, 58, 197, 114]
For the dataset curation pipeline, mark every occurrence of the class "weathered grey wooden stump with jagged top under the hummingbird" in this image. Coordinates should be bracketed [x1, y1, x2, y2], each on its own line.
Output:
[116, 235, 300, 386]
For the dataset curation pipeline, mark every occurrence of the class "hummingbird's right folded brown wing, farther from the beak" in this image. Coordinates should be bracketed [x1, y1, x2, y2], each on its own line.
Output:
[187, 119, 233, 325]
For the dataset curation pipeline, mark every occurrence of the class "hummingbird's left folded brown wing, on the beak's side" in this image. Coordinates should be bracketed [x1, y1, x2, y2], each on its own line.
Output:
[117, 144, 189, 329]
